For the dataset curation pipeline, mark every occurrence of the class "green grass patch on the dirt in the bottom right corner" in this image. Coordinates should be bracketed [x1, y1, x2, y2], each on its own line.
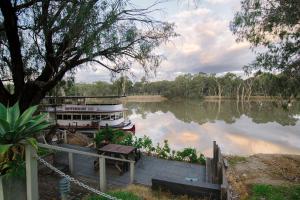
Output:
[250, 184, 300, 200]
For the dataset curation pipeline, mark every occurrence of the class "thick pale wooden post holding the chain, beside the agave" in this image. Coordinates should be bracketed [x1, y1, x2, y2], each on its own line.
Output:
[25, 144, 39, 200]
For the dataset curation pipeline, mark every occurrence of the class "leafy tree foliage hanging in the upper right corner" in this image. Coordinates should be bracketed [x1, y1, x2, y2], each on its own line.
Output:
[231, 0, 300, 76]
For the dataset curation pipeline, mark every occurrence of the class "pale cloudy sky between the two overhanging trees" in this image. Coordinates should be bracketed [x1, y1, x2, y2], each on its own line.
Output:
[75, 0, 254, 83]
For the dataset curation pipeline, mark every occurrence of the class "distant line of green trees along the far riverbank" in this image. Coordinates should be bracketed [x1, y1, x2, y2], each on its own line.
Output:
[49, 71, 300, 100]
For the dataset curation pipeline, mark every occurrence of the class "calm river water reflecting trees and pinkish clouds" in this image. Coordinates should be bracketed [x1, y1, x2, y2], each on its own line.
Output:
[125, 100, 300, 156]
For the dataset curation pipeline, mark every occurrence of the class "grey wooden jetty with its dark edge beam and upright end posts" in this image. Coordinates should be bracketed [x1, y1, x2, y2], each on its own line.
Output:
[49, 142, 230, 200]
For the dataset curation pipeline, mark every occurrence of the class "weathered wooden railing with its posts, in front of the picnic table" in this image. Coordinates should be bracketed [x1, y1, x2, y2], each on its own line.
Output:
[26, 143, 135, 200]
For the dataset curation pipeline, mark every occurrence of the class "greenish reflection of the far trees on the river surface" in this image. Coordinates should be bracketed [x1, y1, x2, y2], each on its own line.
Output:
[126, 100, 300, 126]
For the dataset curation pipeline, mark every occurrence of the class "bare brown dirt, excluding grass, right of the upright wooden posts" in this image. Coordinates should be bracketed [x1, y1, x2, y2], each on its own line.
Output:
[226, 154, 300, 199]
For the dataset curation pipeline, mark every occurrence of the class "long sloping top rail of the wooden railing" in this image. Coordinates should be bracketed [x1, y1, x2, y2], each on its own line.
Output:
[38, 143, 135, 163]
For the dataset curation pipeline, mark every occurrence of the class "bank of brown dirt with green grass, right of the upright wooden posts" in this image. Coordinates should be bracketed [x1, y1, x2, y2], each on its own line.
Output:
[226, 154, 300, 200]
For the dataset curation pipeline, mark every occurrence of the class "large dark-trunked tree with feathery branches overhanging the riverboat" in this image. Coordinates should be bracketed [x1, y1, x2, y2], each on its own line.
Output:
[0, 0, 175, 110]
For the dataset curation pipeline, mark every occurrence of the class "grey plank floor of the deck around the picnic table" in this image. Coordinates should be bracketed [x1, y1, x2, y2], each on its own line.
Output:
[55, 145, 206, 187]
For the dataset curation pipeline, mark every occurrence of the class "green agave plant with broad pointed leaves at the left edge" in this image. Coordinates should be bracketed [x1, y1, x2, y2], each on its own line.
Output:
[0, 103, 50, 176]
